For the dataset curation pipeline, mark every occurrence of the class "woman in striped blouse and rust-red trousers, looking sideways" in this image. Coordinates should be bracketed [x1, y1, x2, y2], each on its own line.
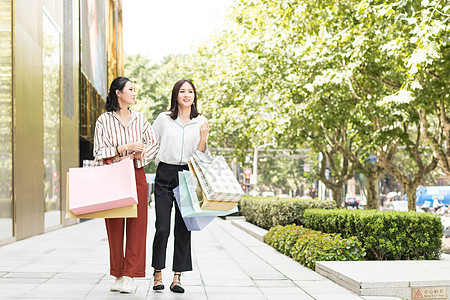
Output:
[94, 77, 158, 293]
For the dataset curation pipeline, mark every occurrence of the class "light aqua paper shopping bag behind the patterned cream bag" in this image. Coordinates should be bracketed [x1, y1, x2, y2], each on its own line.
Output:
[177, 171, 238, 217]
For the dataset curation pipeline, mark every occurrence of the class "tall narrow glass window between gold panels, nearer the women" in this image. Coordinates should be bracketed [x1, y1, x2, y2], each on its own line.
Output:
[43, 11, 61, 228]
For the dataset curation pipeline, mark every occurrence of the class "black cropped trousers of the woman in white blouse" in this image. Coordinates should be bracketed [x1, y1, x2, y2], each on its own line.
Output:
[152, 162, 192, 272]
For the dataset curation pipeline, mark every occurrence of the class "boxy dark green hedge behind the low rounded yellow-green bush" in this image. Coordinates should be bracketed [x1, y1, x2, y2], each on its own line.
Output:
[303, 209, 443, 260]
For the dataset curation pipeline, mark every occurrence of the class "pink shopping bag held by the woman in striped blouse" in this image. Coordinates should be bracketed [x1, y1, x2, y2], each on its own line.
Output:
[69, 158, 138, 215]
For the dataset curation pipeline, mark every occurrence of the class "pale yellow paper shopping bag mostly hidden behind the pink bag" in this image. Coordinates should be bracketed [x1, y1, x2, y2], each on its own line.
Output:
[65, 172, 137, 219]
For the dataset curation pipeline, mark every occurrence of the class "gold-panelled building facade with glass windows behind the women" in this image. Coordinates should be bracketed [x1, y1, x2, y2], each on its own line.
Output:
[0, 0, 123, 245]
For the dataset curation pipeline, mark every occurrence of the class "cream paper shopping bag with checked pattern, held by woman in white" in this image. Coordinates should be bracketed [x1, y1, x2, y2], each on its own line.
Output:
[190, 155, 244, 208]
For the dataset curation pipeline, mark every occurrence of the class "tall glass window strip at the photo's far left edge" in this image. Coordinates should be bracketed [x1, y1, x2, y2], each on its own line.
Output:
[0, 0, 13, 240]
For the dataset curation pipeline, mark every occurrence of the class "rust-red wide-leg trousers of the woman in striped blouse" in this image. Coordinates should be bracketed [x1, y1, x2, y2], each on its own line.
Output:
[105, 167, 148, 277]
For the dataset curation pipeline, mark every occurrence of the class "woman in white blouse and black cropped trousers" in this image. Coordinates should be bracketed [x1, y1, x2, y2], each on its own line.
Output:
[152, 79, 210, 293]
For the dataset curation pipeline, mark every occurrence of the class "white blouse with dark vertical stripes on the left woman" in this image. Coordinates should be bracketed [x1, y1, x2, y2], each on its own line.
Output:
[94, 110, 158, 168]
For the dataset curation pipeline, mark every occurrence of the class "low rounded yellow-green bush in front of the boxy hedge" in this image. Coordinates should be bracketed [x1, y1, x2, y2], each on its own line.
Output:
[264, 224, 365, 270]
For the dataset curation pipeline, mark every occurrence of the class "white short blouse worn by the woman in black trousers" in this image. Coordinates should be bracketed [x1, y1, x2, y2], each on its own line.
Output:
[153, 112, 212, 165]
